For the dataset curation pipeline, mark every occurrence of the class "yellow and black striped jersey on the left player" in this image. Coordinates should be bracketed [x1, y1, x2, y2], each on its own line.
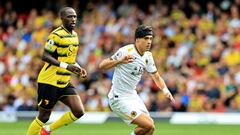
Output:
[38, 26, 79, 88]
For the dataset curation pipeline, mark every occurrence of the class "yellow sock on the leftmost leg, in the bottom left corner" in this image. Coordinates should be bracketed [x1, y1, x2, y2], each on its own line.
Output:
[27, 118, 44, 135]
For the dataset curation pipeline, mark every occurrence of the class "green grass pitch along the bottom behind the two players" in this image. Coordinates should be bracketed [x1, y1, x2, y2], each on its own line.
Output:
[0, 121, 240, 135]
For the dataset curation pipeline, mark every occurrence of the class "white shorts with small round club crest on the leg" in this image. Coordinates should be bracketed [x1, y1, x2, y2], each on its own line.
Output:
[109, 96, 149, 125]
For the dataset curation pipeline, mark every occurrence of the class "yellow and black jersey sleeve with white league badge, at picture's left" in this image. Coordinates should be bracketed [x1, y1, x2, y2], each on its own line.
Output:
[44, 33, 60, 53]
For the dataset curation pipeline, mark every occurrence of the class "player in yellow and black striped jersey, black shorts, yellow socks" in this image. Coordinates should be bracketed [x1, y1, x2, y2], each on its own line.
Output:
[27, 7, 87, 135]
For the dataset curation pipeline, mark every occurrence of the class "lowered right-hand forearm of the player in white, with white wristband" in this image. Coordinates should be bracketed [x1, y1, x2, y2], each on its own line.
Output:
[151, 71, 175, 103]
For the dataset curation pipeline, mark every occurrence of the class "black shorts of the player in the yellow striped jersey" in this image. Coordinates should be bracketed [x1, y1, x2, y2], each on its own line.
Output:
[38, 83, 77, 109]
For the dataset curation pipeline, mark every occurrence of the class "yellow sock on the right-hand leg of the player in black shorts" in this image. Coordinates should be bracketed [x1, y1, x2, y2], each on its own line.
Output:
[50, 112, 78, 131]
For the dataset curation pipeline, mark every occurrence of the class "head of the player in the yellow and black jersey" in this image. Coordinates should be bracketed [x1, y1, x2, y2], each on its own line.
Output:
[62, 9, 77, 30]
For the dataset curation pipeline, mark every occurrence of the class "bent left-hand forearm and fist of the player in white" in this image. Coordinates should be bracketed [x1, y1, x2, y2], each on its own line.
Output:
[99, 55, 134, 71]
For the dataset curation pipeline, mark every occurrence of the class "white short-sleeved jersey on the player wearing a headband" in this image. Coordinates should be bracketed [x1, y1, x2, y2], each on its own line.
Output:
[108, 44, 157, 98]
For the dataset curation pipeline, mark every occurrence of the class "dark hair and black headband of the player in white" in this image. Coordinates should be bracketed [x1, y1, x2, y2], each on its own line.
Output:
[135, 25, 154, 39]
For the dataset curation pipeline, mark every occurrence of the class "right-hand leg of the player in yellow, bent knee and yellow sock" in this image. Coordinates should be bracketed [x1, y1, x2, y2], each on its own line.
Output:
[47, 85, 84, 131]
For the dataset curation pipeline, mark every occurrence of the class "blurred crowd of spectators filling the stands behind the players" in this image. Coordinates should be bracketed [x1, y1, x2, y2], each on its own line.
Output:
[0, 0, 240, 112]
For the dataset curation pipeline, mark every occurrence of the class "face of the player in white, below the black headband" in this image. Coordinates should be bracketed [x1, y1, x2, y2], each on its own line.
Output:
[139, 35, 153, 52]
